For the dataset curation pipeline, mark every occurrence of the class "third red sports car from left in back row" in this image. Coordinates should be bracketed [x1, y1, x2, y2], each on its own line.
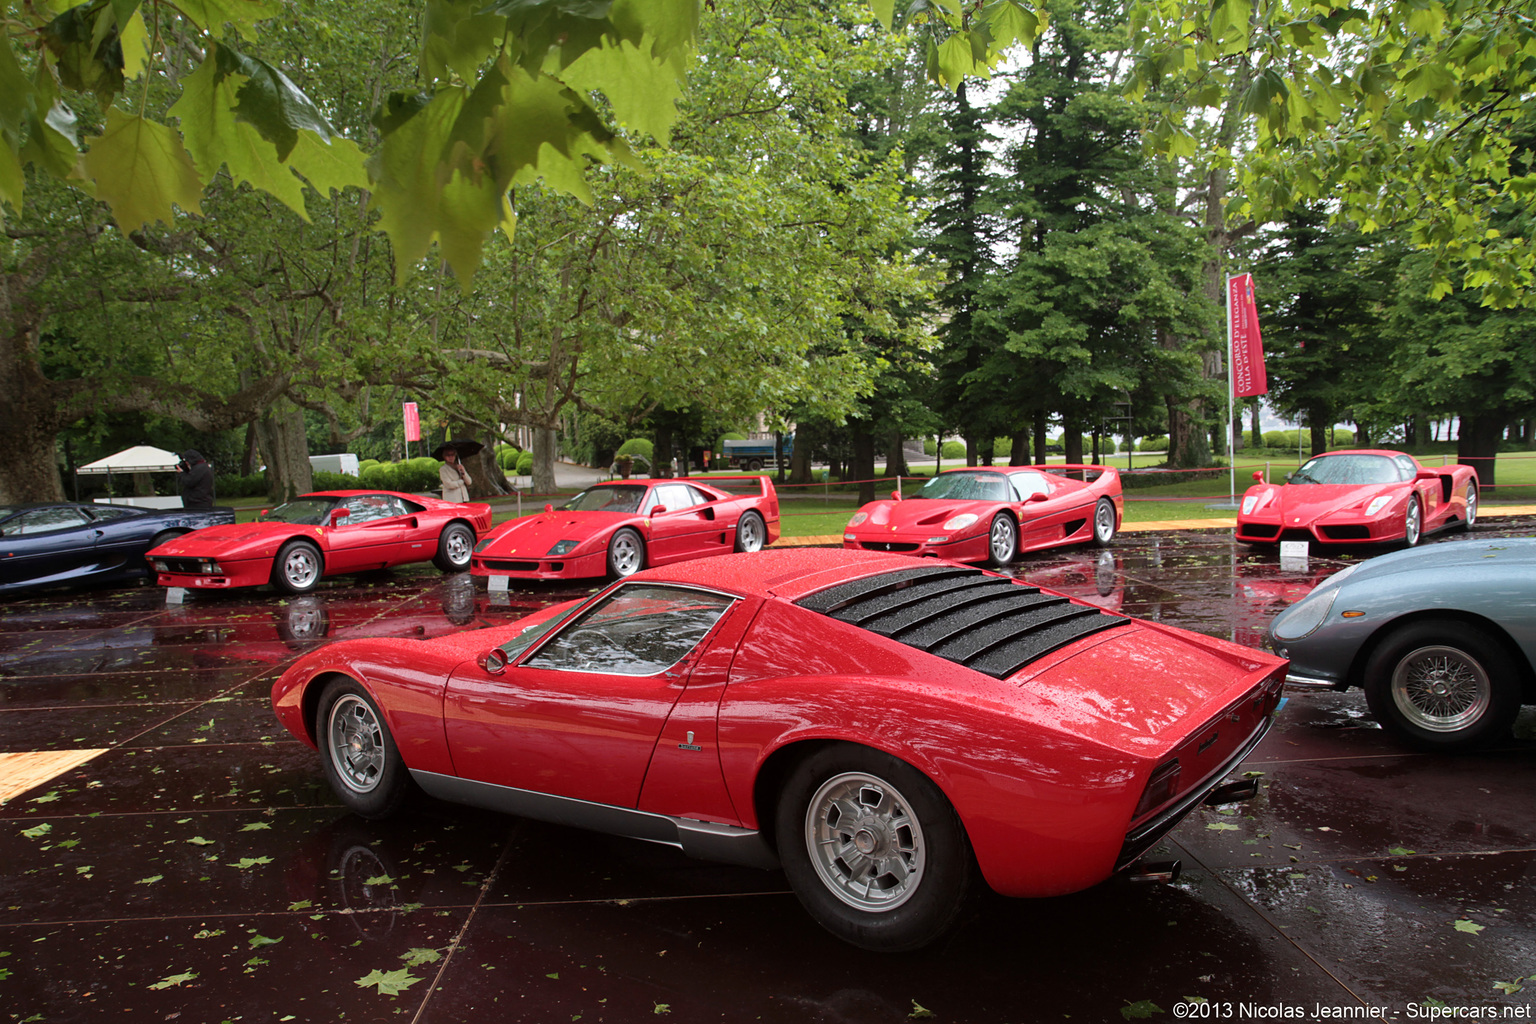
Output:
[843, 465, 1124, 565]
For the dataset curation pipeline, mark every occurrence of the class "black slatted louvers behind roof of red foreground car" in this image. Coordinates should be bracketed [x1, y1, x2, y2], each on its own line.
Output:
[796, 565, 1130, 679]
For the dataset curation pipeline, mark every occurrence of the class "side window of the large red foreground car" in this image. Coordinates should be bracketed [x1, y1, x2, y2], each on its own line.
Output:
[524, 583, 736, 676]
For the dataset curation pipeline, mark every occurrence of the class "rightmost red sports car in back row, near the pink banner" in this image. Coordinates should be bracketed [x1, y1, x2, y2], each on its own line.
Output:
[1236, 448, 1478, 548]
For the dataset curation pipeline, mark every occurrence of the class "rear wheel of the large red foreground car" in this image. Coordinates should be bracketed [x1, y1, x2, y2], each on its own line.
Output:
[774, 743, 975, 952]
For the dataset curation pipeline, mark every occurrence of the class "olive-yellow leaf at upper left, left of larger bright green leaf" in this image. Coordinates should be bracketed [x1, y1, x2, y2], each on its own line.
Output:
[83, 107, 203, 232]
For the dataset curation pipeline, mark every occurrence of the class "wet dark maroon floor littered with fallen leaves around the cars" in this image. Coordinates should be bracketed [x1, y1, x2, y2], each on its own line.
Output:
[0, 517, 1536, 1024]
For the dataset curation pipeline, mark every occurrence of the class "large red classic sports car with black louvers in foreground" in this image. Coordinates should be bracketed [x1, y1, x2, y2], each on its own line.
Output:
[272, 548, 1286, 950]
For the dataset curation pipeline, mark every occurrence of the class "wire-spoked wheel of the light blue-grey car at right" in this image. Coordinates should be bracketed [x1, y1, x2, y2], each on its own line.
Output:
[1364, 619, 1521, 751]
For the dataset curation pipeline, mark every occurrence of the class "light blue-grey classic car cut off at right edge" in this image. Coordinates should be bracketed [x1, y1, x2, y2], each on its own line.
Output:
[1269, 537, 1536, 751]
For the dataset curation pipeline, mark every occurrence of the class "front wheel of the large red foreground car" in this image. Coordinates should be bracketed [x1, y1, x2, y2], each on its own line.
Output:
[315, 679, 410, 820]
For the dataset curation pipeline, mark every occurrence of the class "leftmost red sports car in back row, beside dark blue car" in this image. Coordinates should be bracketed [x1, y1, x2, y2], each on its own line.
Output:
[144, 491, 490, 594]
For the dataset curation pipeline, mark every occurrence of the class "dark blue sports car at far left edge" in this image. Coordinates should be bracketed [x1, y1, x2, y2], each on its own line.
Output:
[0, 502, 235, 594]
